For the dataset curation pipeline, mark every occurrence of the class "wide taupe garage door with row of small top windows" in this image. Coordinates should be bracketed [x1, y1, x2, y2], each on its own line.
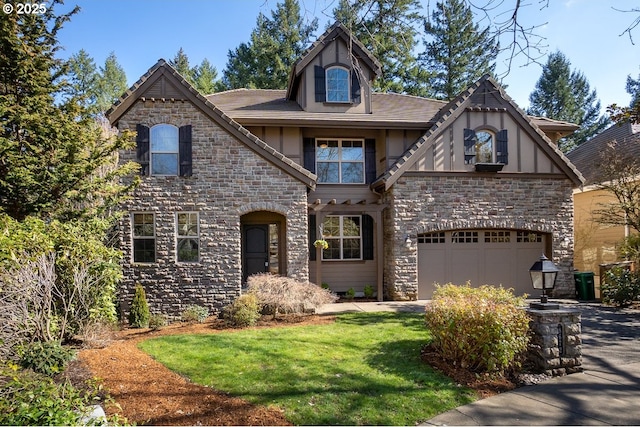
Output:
[418, 230, 546, 299]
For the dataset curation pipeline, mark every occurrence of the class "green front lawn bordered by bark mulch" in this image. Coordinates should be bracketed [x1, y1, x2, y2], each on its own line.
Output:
[140, 313, 474, 425]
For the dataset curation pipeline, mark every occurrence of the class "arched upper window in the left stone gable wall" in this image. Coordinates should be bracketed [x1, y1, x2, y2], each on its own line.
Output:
[150, 124, 180, 175]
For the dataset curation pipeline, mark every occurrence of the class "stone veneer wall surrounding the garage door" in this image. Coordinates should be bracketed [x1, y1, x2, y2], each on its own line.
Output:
[384, 172, 575, 300]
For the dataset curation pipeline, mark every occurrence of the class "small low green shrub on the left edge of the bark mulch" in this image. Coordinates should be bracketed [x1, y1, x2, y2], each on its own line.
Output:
[19, 341, 75, 376]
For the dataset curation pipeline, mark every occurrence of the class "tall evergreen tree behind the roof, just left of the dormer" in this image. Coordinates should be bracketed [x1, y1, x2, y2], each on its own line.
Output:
[222, 0, 318, 89]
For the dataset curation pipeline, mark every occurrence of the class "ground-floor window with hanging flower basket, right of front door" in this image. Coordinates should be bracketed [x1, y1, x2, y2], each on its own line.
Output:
[322, 215, 362, 260]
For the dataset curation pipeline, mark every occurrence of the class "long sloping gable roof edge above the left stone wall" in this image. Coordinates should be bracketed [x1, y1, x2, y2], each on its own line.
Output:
[106, 59, 317, 189]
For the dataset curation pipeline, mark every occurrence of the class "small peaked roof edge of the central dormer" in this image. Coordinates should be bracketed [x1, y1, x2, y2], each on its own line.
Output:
[287, 22, 382, 99]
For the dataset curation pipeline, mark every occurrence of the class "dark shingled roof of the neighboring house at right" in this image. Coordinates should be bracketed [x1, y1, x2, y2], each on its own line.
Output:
[567, 123, 640, 185]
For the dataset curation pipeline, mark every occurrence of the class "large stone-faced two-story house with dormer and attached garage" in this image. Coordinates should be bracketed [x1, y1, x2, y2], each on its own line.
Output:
[108, 24, 582, 314]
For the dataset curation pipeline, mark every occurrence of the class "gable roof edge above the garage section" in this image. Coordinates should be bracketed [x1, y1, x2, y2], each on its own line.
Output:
[372, 74, 584, 190]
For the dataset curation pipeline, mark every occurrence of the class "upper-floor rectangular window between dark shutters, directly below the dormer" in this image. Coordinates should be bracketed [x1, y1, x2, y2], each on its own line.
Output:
[316, 139, 365, 184]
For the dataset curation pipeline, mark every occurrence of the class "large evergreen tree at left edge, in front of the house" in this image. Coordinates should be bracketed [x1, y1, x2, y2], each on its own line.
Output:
[0, 2, 136, 220]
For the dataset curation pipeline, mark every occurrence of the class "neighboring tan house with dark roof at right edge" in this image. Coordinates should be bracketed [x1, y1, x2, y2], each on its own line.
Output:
[567, 123, 640, 287]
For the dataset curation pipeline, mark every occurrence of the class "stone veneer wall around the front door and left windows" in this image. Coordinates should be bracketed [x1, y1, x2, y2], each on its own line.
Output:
[118, 100, 309, 317]
